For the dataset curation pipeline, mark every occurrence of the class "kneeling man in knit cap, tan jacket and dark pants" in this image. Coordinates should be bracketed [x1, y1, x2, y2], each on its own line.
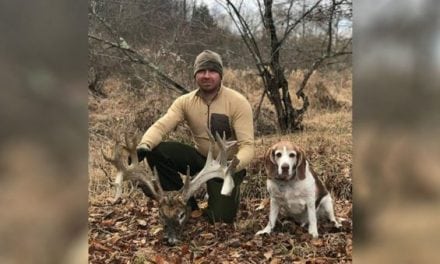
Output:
[137, 50, 254, 223]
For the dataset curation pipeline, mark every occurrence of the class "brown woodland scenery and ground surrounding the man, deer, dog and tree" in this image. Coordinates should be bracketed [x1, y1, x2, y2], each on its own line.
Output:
[89, 0, 352, 263]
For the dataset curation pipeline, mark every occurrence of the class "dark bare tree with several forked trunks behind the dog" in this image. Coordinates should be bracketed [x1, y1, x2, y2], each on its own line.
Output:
[225, 0, 351, 133]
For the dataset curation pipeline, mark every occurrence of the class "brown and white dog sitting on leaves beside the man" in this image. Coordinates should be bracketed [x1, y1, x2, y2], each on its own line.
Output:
[256, 141, 341, 238]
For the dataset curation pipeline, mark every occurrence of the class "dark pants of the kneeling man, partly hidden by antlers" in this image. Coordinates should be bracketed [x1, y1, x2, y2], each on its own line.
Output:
[147, 142, 246, 223]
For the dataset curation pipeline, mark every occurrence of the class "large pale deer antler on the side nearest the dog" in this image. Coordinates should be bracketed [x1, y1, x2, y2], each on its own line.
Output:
[182, 129, 238, 200]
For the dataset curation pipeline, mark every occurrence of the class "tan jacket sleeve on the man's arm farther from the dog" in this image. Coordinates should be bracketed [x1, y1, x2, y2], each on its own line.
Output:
[139, 96, 184, 149]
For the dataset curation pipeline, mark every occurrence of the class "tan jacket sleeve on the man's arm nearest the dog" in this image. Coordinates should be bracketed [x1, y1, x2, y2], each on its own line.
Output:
[232, 98, 255, 171]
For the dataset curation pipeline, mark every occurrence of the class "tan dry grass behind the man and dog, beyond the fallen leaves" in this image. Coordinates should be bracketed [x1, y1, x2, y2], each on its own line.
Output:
[89, 69, 352, 199]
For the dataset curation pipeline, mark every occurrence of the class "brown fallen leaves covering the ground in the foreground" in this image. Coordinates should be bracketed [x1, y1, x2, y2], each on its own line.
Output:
[89, 198, 352, 264]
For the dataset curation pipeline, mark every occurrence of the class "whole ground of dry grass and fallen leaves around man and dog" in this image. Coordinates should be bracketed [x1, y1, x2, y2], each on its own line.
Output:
[89, 69, 353, 264]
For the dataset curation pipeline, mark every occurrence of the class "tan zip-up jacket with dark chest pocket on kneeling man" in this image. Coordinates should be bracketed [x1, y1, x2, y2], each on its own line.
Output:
[139, 85, 254, 171]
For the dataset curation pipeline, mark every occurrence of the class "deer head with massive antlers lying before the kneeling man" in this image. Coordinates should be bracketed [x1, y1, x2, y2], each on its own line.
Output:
[102, 130, 238, 245]
